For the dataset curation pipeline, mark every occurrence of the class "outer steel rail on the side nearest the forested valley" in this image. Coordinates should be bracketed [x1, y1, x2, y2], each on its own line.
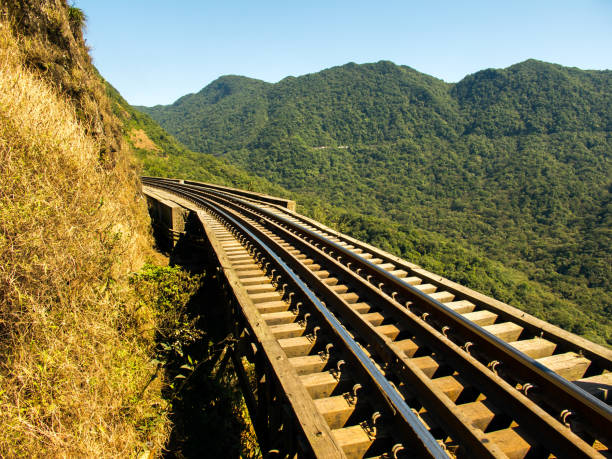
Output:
[145, 178, 611, 452]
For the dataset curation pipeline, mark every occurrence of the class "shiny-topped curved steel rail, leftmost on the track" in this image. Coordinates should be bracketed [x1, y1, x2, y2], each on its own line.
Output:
[186, 189, 448, 458]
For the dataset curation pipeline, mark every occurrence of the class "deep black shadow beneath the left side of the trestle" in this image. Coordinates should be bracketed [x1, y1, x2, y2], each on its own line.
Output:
[154, 222, 251, 458]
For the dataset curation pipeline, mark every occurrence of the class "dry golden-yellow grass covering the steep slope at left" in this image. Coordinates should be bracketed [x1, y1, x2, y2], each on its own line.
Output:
[0, 13, 168, 457]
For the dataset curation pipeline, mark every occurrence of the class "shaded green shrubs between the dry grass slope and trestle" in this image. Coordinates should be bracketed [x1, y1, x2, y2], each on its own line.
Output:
[130, 264, 258, 458]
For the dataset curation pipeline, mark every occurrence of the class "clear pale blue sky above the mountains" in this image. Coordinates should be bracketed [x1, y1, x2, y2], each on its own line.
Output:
[75, 0, 612, 105]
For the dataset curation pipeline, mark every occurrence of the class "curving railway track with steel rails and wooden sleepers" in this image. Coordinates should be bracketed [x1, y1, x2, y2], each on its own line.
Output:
[143, 178, 612, 457]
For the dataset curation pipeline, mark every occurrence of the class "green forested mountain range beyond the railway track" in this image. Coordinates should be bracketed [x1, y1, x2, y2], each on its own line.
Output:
[140, 60, 612, 339]
